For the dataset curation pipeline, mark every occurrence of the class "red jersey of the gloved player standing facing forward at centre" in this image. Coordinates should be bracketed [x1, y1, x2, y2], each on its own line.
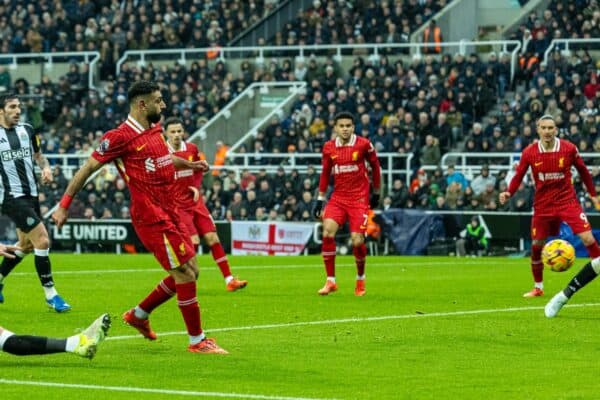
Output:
[319, 135, 381, 202]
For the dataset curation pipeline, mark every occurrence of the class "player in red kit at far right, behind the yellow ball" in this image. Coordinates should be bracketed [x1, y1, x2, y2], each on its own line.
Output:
[500, 115, 600, 297]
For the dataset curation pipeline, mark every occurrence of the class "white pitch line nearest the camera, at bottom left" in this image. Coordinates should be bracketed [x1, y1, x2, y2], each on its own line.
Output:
[0, 378, 333, 400]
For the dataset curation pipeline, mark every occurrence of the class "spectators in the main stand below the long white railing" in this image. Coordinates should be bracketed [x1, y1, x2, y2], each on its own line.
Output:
[0, 0, 600, 221]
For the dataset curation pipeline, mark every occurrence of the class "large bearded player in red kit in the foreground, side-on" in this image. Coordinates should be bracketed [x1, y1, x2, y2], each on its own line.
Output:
[52, 81, 227, 354]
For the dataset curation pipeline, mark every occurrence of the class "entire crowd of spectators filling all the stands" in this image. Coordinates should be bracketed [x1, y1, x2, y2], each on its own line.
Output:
[0, 1, 600, 220]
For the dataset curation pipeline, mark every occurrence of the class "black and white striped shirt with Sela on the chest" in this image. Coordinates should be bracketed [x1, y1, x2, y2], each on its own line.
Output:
[0, 123, 40, 203]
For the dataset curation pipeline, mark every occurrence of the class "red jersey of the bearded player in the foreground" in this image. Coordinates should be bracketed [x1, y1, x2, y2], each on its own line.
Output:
[92, 116, 176, 224]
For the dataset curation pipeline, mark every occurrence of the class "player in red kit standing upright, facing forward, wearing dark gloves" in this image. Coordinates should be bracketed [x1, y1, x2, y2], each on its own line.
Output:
[313, 112, 381, 296]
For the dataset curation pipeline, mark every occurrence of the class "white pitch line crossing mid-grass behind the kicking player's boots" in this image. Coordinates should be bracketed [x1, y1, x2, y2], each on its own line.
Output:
[106, 303, 600, 340]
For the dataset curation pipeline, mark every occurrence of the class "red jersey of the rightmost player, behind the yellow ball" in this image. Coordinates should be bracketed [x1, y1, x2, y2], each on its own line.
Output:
[508, 138, 596, 215]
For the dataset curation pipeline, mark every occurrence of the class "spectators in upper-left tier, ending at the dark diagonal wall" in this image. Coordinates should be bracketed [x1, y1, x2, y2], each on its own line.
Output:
[0, 0, 279, 80]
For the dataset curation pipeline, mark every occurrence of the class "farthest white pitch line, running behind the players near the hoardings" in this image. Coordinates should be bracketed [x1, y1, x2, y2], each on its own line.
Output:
[11, 261, 478, 276]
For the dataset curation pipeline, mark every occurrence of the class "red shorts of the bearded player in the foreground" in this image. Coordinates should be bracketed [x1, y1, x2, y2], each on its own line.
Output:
[134, 219, 196, 271]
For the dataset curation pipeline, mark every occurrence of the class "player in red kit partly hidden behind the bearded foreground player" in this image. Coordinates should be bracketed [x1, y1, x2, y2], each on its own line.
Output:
[163, 117, 248, 292]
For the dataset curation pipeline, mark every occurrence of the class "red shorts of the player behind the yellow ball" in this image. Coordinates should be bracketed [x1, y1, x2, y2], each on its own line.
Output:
[531, 203, 592, 240]
